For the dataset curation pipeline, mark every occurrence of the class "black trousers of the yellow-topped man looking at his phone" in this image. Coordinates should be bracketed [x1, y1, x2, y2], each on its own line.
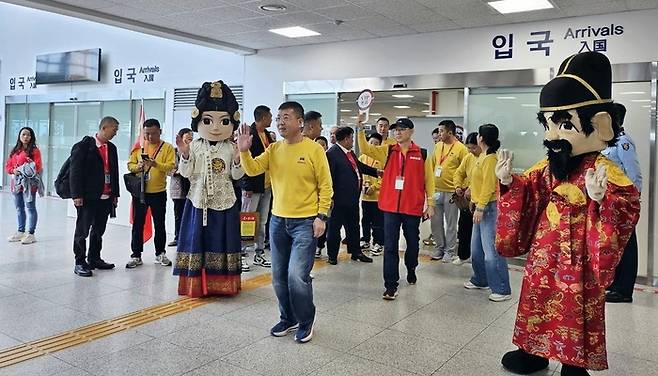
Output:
[130, 191, 167, 257]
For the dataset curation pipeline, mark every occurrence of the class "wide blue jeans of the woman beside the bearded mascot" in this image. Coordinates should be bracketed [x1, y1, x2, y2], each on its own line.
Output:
[471, 201, 512, 295]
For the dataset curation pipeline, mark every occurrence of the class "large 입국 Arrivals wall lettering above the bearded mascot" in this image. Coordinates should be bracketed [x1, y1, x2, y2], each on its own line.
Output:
[491, 23, 624, 60]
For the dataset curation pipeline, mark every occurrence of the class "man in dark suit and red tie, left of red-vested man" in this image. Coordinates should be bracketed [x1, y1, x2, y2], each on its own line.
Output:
[327, 127, 377, 265]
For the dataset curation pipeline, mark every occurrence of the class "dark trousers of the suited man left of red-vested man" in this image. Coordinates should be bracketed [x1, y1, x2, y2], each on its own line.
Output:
[327, 203, 361, 260]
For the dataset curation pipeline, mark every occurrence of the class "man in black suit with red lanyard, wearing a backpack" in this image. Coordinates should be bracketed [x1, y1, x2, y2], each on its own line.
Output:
[69, 116, 119, 277]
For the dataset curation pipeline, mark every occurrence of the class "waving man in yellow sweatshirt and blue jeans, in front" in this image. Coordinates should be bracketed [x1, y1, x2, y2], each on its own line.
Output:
[238, 102, 333, 343]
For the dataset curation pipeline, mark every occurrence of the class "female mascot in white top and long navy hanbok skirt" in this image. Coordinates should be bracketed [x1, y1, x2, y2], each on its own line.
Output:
[174, 81, 244, 298]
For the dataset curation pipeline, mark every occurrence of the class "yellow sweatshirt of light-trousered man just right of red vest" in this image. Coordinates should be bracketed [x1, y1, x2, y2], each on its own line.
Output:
[432, 141, 469, 192]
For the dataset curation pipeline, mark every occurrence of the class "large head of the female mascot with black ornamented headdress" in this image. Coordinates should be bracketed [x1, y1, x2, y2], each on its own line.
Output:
[192, 81, 240, 141]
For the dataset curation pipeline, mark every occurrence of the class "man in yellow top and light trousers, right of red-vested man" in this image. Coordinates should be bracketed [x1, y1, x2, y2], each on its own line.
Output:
[431, 120, 468, 262]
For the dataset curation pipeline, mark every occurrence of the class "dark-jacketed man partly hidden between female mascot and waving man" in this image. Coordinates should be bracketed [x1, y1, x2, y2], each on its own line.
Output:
[242, 105, 274, 272]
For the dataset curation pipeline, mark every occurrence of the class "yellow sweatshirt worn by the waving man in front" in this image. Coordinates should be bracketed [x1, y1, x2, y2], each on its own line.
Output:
[240, 137, 333, 218]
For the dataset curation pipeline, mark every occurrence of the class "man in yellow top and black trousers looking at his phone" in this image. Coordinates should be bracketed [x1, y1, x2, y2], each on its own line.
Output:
[126, 119, 176, 269]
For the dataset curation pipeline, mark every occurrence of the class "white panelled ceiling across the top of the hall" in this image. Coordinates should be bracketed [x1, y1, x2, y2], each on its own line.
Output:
[8, 0, 658, 53]
